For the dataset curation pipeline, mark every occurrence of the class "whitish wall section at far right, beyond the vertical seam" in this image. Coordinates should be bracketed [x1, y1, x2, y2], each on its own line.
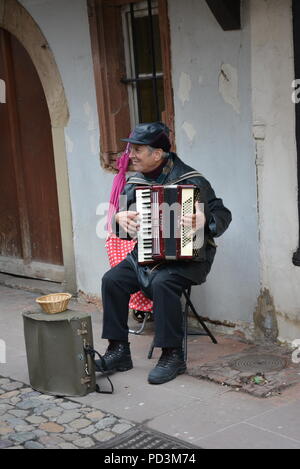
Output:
[251, 0, 300, 340]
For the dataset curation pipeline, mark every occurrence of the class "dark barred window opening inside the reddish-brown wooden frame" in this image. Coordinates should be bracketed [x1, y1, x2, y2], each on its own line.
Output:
[122, 0, 164, 127]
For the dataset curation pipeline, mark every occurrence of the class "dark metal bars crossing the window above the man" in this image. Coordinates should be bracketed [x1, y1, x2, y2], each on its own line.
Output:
[121, 0, 163, 121]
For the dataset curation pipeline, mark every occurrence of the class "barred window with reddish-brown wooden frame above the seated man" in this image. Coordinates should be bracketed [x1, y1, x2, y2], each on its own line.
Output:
[88, 0, 174, 169]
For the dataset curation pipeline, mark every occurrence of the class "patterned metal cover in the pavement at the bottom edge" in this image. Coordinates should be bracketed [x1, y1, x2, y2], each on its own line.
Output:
[95, 427, 199, 449]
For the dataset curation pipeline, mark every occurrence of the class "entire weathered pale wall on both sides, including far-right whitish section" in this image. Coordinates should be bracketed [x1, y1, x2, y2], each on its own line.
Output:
[14, 0, 300, 340]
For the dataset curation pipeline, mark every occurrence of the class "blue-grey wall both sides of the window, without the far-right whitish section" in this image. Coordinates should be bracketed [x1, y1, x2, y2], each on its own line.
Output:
[15, 0, 259, 322]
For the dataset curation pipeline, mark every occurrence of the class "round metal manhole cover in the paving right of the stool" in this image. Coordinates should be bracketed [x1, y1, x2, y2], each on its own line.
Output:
[229, 354, 286, 373]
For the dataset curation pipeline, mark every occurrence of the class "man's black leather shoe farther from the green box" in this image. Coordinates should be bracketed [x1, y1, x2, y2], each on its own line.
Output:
[148, 348, 186, 384]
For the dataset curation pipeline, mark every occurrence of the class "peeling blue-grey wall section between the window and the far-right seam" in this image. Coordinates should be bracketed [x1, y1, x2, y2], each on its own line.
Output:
[169, 0, 259, 323]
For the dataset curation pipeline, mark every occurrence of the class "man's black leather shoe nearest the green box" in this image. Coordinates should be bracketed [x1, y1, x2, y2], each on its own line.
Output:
[96, 341, 133, 371]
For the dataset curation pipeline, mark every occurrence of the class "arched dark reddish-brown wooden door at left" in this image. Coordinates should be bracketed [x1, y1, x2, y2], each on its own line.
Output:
[0, 28, 64, 282]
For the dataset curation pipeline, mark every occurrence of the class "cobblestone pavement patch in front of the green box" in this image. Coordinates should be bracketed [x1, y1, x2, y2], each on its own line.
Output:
[0, 377, 135, 449]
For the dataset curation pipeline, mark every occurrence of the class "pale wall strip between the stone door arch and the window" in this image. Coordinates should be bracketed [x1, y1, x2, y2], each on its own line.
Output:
[21, 0, 112, 296]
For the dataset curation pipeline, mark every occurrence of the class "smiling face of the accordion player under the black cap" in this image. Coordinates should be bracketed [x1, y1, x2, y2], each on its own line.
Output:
[130, 144, 163, 173]
